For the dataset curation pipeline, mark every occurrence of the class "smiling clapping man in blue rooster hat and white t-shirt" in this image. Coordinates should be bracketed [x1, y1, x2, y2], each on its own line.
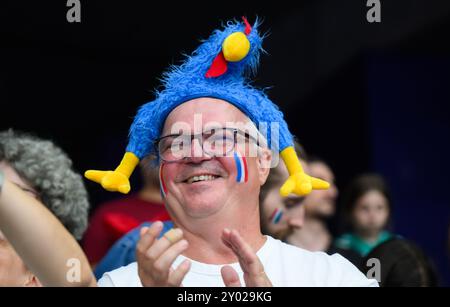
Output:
[0, 19, 377, 286]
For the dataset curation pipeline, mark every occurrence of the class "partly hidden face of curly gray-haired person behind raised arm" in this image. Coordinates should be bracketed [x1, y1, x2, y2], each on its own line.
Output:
[0, 162, 39, 286]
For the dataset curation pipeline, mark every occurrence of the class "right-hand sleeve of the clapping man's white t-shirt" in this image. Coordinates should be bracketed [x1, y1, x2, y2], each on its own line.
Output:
[329, 254, 378, 287]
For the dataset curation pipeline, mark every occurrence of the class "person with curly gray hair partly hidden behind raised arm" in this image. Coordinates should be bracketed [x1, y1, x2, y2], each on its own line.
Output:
[0, 130, 89, 286]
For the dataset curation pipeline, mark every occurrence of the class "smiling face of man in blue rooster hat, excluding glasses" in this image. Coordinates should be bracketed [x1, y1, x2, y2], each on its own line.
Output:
[161, 98, 270, 223]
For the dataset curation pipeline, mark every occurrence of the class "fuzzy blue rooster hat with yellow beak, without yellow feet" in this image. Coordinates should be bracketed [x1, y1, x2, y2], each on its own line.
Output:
[127, 18, 293, 159]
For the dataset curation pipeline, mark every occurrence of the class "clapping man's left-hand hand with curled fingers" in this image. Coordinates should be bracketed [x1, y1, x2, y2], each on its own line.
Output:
[136, 222, 191, 287]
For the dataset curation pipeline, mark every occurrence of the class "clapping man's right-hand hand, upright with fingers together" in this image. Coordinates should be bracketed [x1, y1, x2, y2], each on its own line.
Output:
[221, 229, 272, 287]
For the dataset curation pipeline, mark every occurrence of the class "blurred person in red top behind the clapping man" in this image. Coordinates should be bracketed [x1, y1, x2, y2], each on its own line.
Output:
[82, 158, 170, 266]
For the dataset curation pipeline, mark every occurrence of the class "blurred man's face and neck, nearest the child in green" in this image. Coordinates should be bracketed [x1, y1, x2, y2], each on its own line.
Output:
[288, 157, 338, 253]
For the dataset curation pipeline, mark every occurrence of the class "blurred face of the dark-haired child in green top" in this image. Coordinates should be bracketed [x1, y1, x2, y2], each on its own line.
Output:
[353, 190, 389, 235]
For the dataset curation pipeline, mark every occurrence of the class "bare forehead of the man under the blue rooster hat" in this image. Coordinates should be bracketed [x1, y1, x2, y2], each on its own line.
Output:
[163, 97, 248, 133]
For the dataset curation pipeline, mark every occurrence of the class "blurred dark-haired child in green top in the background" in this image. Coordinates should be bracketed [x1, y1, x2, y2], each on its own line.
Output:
[334, 174, 393, 266]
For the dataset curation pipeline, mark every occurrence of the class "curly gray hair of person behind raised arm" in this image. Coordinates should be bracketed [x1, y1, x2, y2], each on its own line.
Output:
[0, 130, 89, 240]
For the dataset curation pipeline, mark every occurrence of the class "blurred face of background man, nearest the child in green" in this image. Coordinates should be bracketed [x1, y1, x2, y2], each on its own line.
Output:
[305, 162, 338, 217]
